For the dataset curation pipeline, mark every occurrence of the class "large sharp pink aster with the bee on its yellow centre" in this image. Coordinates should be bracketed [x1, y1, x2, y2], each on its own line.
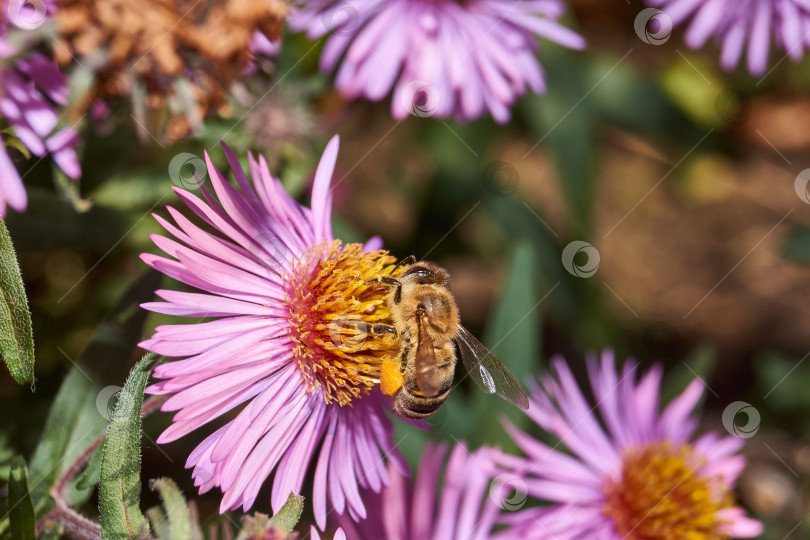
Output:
[141, 137, 406, 528]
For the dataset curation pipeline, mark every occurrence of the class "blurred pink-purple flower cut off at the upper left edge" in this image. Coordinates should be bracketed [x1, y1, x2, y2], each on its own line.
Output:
[0, 0, 81, 217]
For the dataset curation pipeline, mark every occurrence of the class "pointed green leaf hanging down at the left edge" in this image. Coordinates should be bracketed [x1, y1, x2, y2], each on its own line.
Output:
[0, 219, 34, 384]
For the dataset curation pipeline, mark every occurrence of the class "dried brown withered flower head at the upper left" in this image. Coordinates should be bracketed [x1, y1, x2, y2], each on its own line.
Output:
[55, 0, 287, 140]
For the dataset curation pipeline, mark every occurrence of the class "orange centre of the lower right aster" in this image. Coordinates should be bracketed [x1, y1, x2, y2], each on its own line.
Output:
[604, 441, 733, 540]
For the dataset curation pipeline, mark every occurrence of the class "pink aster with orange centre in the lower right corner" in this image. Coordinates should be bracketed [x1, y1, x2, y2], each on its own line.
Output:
[495, 353, 762, 540]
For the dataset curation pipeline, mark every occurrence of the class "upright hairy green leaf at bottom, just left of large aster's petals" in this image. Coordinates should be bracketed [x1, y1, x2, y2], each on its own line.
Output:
[98, 353, 155, 539]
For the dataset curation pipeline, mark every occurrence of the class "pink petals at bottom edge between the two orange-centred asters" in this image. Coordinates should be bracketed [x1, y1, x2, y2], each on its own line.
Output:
[336, 443, 501, 540]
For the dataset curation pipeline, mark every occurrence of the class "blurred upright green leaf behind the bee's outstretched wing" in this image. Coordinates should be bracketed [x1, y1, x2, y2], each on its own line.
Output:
[468, 242, 542, 450]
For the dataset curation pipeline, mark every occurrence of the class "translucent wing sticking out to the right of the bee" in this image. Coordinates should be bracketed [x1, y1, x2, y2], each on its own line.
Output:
[456, 325, 529, 409]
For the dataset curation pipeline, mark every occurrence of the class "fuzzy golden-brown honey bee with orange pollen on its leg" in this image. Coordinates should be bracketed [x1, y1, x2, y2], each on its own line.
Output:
[369, 257, 529, 419]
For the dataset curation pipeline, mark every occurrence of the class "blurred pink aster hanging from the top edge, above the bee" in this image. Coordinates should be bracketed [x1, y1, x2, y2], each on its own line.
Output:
[288, 0, 585, 122]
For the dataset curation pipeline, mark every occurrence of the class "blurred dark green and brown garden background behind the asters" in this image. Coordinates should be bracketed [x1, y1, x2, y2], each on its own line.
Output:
[0, 0, 810, 539]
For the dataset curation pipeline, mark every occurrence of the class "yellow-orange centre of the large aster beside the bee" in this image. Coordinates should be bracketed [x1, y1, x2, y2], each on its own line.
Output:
[285, 240, 402, 405]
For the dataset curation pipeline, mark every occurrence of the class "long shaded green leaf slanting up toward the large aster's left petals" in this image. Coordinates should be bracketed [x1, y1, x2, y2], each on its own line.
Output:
[27, 272, 160, 520]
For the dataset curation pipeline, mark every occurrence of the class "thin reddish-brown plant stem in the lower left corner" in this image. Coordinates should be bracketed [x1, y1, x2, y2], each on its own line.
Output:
[36, 396, 166, 540]
